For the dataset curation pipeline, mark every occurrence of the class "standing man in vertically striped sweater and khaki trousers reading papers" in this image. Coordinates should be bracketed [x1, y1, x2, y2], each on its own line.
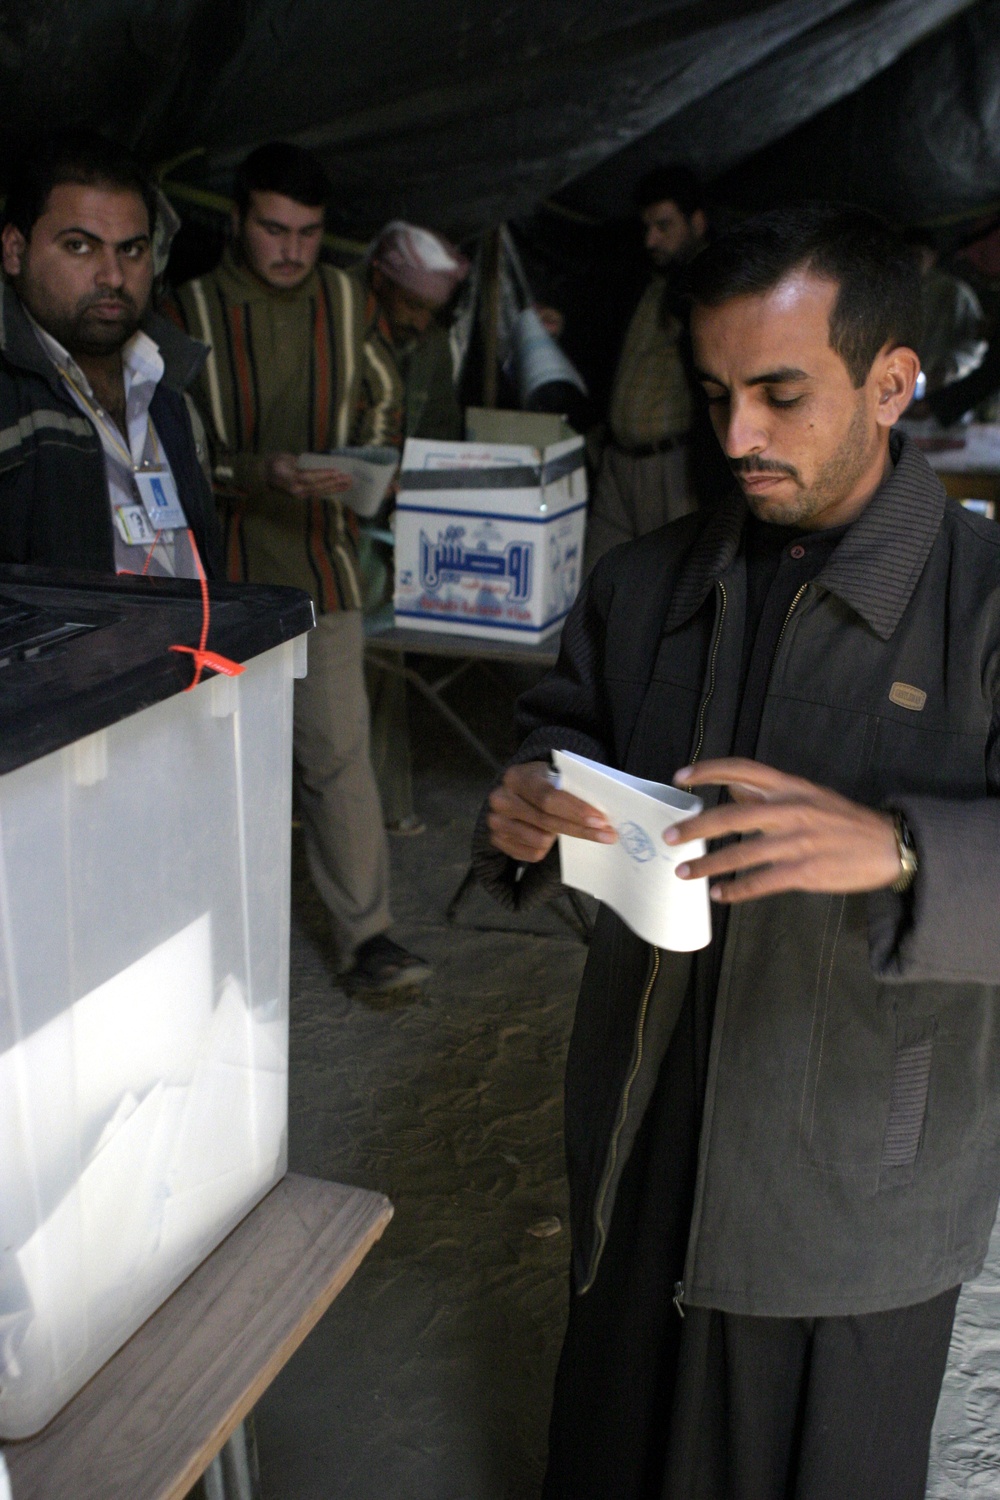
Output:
[178, 144, 430, 993]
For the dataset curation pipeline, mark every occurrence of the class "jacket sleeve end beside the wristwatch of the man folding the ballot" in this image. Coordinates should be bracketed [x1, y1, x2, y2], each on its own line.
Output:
[868, 797, 1000, 984]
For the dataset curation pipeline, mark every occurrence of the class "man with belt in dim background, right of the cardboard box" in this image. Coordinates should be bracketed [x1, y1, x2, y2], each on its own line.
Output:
[585, 167, 708, 572]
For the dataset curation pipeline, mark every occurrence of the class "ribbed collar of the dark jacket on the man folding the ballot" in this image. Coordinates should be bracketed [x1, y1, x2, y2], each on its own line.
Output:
[664, 434, 945, 641]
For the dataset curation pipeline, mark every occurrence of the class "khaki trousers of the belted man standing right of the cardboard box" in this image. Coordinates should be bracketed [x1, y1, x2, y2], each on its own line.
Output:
[583, 443, 697, 573]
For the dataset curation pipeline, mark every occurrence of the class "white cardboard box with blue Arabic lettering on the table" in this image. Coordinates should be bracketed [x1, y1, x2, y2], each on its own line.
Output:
[394, 437, 586, 642]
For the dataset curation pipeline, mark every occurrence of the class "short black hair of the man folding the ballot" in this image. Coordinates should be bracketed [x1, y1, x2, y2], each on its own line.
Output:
[690, 203, 921, 387]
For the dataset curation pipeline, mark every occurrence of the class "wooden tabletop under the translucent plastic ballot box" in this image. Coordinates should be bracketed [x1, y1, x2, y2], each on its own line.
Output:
[3, 1175, 393, 1500]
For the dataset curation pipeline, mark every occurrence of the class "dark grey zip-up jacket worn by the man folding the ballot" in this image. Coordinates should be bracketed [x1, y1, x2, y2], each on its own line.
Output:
[475, 444, 1000, 1317]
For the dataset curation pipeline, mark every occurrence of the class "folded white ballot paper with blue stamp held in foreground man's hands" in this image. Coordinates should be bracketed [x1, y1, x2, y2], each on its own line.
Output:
[553, 750, 712, 953]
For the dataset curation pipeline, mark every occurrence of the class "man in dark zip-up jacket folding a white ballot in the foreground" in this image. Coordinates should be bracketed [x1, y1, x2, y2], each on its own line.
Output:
[477, 207, 1000, 1500]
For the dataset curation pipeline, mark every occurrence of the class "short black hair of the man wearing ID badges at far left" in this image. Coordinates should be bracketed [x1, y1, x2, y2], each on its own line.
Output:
[3, 129, 156, 239]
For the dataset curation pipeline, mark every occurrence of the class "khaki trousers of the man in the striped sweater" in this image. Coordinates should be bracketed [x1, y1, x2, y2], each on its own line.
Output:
[292, 609, 391, 968]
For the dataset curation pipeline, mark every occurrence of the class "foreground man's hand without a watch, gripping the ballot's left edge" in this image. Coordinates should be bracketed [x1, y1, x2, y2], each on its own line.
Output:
[487, 761, 618, 864]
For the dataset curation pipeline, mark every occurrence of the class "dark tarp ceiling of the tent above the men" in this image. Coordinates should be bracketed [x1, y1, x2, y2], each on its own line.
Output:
[0, 0, 1000, 234]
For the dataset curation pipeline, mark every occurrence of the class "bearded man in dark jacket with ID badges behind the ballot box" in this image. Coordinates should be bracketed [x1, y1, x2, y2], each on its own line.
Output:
[0, 132, 217, 578]
